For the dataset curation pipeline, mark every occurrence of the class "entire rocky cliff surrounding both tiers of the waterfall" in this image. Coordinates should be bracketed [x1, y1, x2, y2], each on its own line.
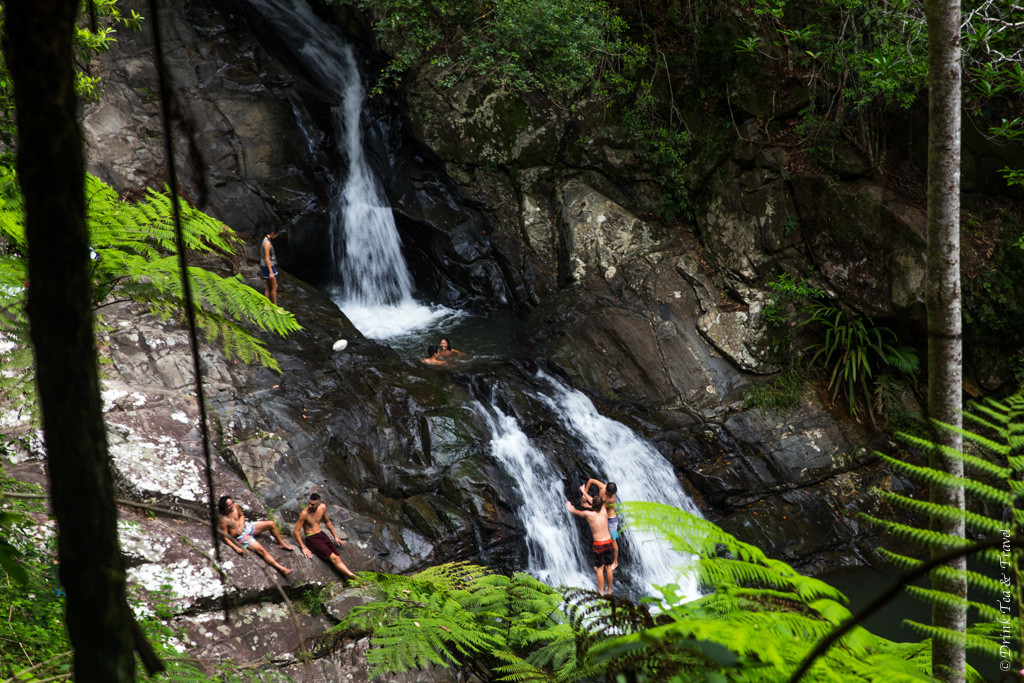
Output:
[8, 0, 1012, 680]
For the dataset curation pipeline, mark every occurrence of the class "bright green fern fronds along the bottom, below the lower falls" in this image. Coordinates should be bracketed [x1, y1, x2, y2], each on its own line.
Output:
[333, 503, 932, 683]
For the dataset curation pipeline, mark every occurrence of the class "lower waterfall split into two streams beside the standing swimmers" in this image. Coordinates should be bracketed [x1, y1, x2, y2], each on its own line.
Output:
[476, 373, 700, 598]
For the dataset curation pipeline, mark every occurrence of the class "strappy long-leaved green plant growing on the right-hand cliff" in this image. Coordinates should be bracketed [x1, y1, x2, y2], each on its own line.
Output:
[803, 301, 920, 420]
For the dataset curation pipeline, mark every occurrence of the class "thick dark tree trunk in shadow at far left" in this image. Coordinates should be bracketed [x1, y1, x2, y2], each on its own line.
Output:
[4, 0, 134, 683]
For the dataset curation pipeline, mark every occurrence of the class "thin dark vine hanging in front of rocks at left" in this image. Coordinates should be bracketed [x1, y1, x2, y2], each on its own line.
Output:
[150, 0, 230, 622]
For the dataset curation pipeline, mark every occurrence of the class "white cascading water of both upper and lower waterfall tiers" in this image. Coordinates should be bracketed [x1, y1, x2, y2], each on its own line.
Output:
[249, 0, 697, 596]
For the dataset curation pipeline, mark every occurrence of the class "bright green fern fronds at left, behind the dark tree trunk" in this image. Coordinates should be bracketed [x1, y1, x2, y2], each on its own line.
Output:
[0, 168, 300, 417]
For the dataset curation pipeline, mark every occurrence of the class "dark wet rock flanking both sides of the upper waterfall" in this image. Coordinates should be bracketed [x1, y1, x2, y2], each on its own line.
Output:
[82, 0, 515, 306]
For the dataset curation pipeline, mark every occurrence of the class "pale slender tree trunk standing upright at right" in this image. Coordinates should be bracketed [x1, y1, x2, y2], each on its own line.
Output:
[925, 0, 967, 681]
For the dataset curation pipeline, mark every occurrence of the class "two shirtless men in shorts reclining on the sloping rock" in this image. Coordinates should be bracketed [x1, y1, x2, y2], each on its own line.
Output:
[217, 494, 355, 579]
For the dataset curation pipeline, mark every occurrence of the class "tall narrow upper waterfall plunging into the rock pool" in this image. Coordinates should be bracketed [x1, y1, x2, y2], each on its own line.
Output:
[243, 0, 452, 339]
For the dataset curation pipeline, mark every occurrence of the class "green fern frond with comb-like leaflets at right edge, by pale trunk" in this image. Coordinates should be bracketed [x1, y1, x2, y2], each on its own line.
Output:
[864, 392, 1024, 670]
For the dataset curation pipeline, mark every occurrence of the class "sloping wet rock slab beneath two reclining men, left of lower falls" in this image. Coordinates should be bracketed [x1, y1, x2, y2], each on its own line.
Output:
[3, 270, 522, 671]
